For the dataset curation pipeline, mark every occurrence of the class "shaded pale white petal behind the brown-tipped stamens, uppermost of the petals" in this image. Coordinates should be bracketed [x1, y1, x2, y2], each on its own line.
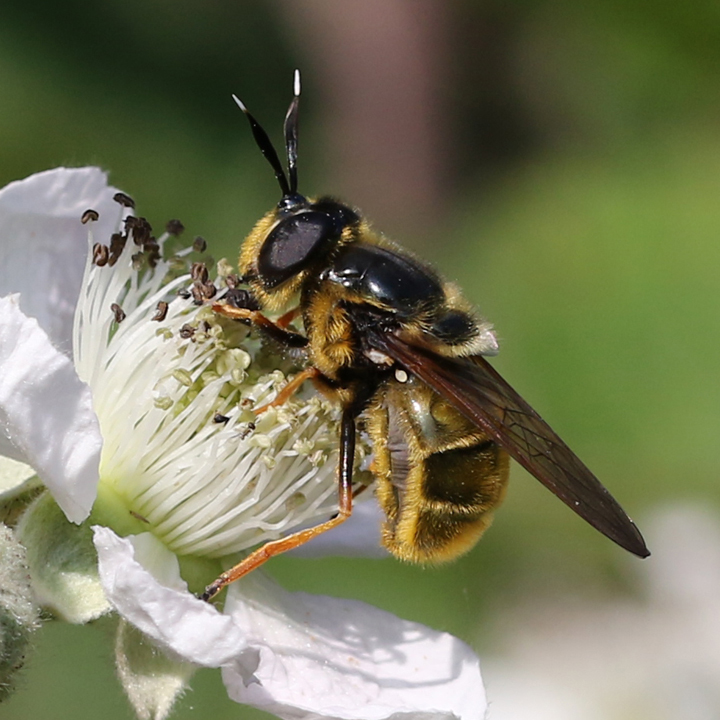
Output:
[0, 167, 120, 356]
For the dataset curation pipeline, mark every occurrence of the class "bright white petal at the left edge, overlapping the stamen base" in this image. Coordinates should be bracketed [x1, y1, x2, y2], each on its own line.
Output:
[0, 295, 102, 522]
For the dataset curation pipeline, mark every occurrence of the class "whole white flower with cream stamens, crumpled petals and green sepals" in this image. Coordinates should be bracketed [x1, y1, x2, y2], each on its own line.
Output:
[0, 168, 485, 720]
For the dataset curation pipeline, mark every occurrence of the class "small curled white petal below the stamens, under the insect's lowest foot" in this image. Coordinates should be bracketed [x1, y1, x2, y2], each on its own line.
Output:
[93, 526, 254, 667]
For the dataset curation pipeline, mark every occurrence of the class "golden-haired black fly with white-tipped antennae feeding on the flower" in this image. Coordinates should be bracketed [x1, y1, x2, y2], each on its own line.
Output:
[202, 72, 649, 600]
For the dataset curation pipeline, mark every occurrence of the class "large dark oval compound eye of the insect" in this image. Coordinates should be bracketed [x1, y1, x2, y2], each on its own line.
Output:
[258, 210, 339, 288]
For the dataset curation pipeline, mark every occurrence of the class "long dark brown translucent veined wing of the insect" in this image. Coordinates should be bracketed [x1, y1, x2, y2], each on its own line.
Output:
[368, 330, 650, 557]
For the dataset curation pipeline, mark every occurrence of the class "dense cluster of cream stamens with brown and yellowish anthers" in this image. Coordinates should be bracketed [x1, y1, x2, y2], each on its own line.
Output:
[74, 196, 364, 557]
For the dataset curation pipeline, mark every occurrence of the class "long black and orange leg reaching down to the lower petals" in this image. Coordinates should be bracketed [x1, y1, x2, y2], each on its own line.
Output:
[200, 405, 358, 601]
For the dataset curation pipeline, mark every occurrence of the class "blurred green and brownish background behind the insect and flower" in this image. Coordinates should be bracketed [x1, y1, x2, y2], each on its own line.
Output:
[0, 0, 720, 720]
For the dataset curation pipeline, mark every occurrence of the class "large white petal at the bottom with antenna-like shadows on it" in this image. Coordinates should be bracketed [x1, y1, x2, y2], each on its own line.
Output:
[223, 573, 486, 720]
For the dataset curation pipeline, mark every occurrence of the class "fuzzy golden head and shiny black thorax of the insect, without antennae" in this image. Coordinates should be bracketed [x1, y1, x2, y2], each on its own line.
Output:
[241, 194, 484, 385]
